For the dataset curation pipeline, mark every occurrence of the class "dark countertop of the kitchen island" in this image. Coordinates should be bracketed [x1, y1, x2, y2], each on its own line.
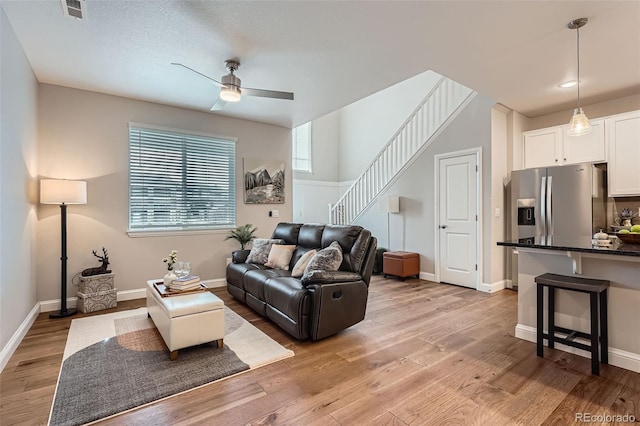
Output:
[498, 237, 640, 257]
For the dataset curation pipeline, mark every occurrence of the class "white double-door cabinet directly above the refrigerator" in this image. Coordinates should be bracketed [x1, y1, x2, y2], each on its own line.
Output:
[522, 120, 606, 169]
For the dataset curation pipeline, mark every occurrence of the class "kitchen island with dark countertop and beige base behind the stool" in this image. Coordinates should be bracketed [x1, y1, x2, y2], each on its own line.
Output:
[498, 237, 640, 372]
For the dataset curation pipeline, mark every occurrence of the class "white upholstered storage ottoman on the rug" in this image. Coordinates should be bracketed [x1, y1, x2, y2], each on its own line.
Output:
[147, 280, 224, 360]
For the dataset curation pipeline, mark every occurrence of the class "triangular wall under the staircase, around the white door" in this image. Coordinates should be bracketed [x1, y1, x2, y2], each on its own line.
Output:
[358, 95, 495, 284]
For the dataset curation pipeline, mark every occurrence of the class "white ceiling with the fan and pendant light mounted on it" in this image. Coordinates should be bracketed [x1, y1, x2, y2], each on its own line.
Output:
[1, 0, 640, 127]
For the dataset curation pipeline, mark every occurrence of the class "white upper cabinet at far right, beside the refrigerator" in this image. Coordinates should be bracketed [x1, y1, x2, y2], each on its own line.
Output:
[606, 111, 640, 197]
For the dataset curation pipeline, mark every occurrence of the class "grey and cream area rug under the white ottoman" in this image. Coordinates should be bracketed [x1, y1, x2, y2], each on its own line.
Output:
[49, 307, 293, 425]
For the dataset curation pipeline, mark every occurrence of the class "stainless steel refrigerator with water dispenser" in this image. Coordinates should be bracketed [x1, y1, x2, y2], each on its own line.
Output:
[511, 163, 607, 286]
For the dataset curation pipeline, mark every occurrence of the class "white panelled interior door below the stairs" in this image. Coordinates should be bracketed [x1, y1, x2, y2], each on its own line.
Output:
[436, 154, 478, 288]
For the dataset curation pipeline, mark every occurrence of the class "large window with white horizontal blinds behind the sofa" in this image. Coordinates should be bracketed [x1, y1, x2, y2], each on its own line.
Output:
[129, 123, 236, 232]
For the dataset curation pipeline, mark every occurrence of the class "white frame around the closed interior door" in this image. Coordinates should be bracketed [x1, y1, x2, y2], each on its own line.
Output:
[433, 147, 483, 290]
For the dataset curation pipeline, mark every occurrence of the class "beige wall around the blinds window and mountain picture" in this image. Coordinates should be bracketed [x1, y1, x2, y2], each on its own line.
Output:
[37, 84, 292, 301]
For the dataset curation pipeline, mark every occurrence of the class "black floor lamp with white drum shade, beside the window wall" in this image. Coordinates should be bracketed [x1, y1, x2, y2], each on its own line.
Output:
[40, 179, 87, 318]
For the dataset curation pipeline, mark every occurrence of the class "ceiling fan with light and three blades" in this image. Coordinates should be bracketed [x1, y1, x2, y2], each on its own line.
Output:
[171, 59, 293, 111]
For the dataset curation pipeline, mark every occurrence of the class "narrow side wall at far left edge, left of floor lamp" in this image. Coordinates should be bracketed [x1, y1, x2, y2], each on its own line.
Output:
[0, 9, 38, 358]
